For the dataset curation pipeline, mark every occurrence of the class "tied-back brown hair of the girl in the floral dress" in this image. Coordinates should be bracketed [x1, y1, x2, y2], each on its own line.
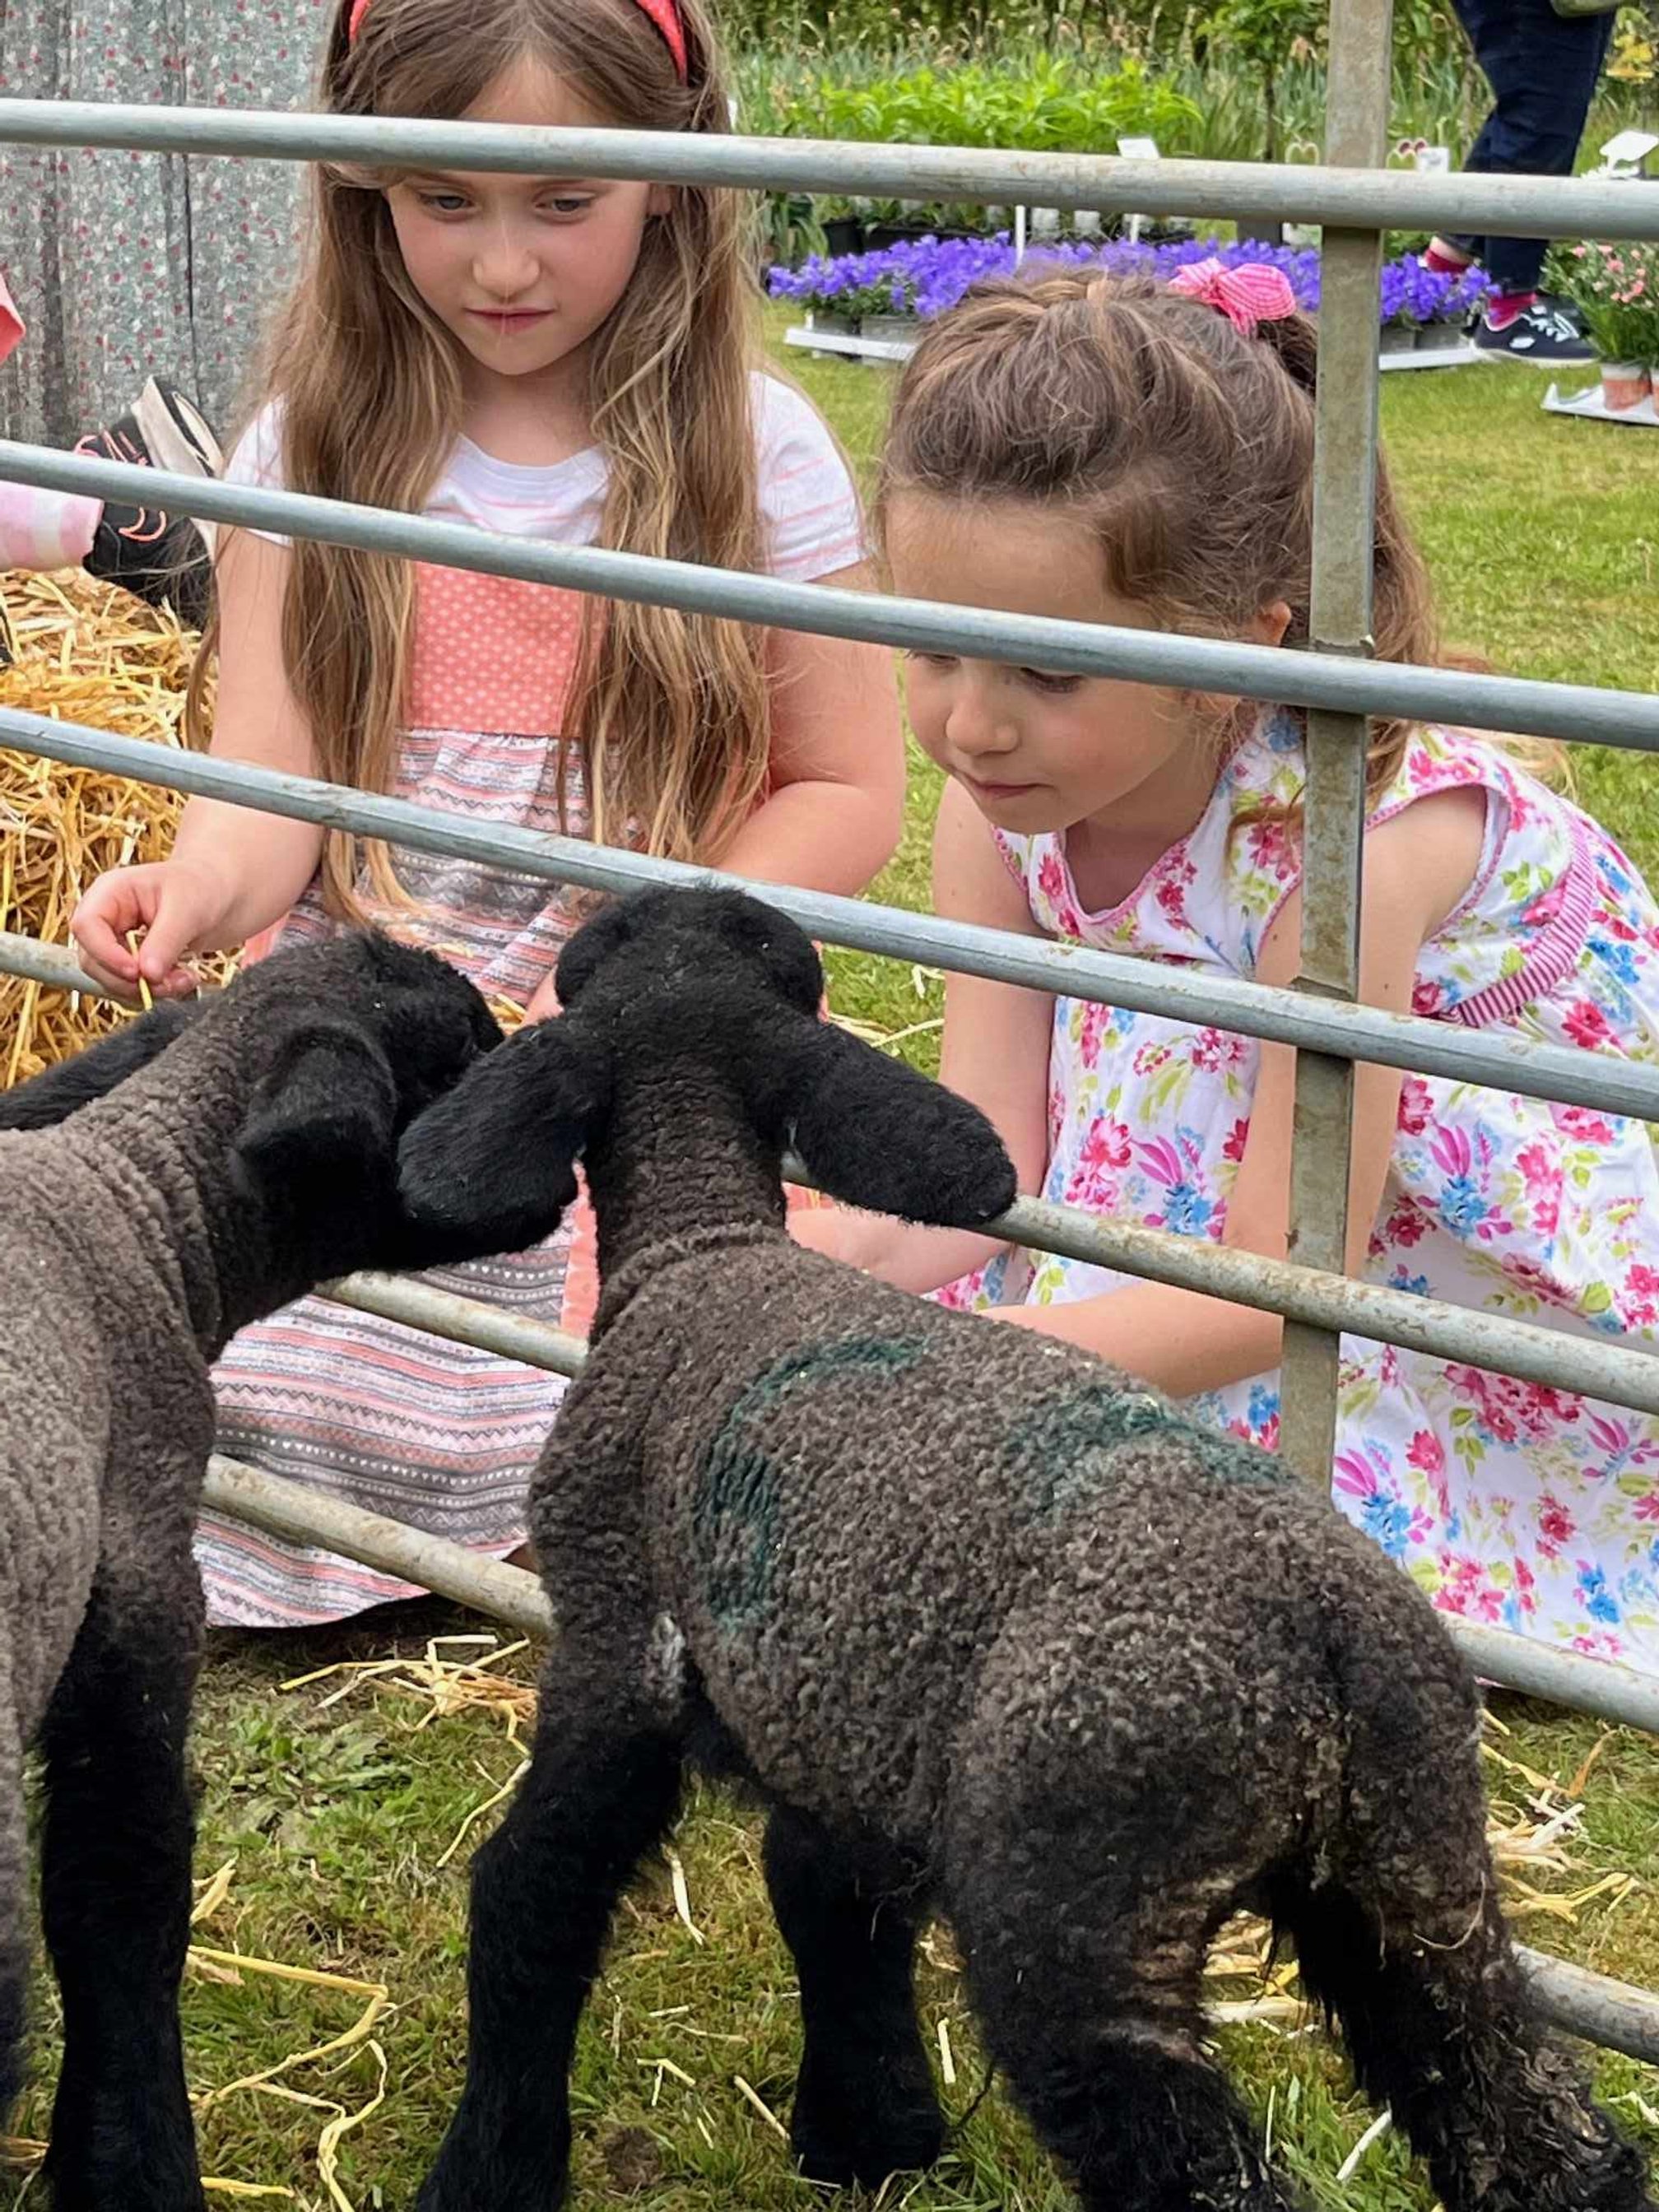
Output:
[878, 272, 1440, 790]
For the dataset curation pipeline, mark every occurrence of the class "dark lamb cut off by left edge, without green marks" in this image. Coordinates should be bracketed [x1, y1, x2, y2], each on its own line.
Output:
[0, 936, 500, 2212]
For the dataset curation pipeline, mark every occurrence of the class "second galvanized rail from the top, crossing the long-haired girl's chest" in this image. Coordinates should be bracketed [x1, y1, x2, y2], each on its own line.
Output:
[0, 439, 1659, 752]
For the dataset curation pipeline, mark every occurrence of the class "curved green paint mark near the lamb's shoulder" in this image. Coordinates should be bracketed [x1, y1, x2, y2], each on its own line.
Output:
[692, 1336, 927, 1633]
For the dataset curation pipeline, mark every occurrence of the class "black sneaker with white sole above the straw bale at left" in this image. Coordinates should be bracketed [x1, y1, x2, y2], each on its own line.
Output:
[75, 379, 221, 630]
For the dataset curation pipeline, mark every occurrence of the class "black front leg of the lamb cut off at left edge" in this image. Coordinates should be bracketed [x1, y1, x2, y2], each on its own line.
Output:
[40, 1574, 203, 2212]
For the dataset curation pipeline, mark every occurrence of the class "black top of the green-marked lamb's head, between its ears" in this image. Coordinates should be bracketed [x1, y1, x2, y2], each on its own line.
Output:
[557, 890, 823, 1013]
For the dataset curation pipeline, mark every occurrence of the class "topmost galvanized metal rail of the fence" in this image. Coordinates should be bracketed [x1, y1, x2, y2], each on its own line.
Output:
[0, 100, 1659, 239]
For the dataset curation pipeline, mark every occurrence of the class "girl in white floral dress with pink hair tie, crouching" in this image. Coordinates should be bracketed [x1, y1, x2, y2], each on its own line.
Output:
[798, 263, 1659, 1670]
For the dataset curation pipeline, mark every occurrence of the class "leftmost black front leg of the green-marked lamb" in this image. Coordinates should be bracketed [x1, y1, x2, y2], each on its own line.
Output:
[418, 1672, 679, 2212]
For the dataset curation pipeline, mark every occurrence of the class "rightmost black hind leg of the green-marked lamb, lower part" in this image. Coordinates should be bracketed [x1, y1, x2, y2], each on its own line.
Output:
[1276, 1866, 1652, 2212]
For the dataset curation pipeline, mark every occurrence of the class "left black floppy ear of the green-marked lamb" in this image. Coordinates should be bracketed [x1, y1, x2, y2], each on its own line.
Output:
[398, 1013, 611, 1252]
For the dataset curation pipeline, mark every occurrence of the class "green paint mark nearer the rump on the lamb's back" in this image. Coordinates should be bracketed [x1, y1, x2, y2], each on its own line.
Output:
[1009, 1382, 1294, 1520]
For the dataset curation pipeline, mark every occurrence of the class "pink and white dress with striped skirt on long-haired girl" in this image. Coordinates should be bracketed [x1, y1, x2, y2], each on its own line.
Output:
[199, 374, 865, 1626]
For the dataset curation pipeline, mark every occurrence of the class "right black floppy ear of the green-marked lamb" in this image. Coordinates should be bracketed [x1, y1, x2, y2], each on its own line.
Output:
[768, 1015, 1017, 1228]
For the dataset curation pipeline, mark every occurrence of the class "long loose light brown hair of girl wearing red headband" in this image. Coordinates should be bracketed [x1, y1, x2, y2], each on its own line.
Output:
[197, 0, 768, 918]
